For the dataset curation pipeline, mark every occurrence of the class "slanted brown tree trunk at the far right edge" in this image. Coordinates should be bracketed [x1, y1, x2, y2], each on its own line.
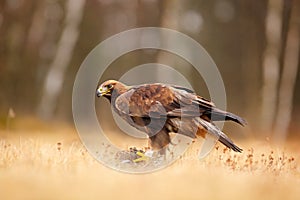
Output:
[274, 1, 300, 142]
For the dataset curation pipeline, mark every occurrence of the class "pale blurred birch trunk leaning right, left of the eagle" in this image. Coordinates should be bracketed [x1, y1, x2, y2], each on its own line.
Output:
[38, 0, 85, 118]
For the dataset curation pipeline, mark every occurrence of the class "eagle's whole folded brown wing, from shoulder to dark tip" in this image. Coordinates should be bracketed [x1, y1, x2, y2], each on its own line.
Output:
[115, 84, 246, 125]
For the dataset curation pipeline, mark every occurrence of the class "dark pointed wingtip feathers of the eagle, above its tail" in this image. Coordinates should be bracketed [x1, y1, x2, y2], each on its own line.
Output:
[205, 108, 247, 126]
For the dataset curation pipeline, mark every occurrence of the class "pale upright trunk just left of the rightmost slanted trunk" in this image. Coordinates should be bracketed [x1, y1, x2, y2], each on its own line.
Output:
[261, 0, 283, 134]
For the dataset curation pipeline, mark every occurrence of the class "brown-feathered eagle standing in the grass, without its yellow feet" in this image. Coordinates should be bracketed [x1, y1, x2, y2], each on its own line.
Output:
[97, 80, 246, 152]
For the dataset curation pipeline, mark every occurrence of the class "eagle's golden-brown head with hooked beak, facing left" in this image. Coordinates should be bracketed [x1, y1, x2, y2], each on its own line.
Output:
[96, 80, 127, 99]
